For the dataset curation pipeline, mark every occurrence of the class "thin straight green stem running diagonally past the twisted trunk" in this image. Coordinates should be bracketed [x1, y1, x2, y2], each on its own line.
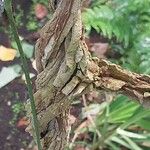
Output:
[5, 0, 42, 150]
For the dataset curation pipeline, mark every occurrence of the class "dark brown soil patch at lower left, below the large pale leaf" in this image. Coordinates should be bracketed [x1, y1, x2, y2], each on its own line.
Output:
[0, 79, 31, 150]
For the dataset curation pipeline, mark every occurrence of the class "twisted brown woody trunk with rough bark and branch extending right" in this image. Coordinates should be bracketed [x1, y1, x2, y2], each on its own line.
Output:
[26, 0, 150, 150]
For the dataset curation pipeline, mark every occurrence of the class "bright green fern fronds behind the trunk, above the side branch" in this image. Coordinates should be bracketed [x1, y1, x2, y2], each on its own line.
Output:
[83, 0, 150, 74]
